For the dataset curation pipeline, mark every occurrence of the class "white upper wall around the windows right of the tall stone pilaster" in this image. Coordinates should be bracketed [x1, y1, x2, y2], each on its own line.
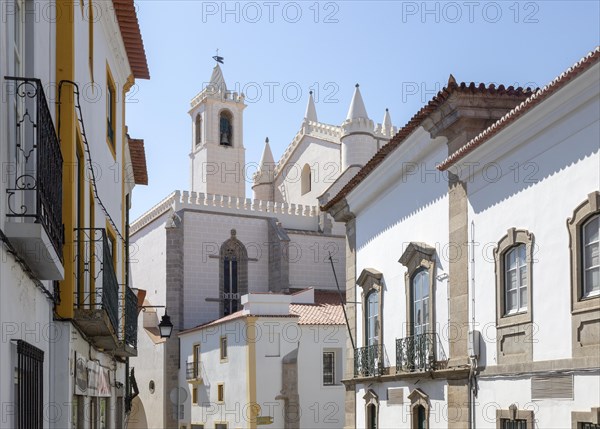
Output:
[467, 83, 600, 365]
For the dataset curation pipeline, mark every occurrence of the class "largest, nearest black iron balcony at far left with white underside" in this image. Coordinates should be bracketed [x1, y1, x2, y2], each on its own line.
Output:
[5, 77, 64, 280]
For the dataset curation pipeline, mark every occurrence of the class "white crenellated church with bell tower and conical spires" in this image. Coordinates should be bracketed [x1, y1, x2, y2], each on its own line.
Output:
[129, 64, 397, 428]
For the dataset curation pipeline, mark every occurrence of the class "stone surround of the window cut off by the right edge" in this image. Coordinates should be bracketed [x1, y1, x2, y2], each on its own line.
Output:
[567, 191, 600, 314]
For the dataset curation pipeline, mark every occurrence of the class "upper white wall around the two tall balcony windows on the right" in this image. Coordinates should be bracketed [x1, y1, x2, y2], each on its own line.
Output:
[348, 130, 449, 362]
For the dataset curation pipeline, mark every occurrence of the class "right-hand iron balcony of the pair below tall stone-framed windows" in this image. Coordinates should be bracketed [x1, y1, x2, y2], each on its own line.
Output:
[396, 332, 447, 372]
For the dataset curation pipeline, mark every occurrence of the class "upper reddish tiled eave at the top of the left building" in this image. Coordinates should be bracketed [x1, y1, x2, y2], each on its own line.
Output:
[113, 0, 150, 79]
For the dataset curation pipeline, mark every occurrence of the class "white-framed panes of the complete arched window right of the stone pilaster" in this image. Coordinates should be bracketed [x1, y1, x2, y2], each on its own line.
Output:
[504, 243, 529, 315]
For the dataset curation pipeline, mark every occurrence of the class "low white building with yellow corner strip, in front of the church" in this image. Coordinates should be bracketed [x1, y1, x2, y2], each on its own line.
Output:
[179, 289, 345, 428]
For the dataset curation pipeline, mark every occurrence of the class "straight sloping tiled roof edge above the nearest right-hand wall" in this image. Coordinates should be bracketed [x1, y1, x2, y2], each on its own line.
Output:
[438, 46, 600, 170]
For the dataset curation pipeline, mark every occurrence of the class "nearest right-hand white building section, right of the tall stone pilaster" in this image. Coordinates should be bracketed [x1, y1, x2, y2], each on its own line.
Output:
[443, 49, 600, 429]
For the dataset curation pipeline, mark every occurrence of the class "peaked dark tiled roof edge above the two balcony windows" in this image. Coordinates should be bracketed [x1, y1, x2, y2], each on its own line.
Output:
[321, 79, 536, 211]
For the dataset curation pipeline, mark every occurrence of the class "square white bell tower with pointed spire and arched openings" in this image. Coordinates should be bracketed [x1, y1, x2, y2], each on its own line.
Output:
[189, 61, 246, 198]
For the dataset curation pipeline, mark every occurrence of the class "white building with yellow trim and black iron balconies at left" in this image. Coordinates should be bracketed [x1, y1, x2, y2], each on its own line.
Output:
[0, 0, 149, 428]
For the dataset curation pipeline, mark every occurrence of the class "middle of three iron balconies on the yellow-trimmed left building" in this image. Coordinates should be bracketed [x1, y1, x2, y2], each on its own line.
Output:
[74, 228, 119, 350]
